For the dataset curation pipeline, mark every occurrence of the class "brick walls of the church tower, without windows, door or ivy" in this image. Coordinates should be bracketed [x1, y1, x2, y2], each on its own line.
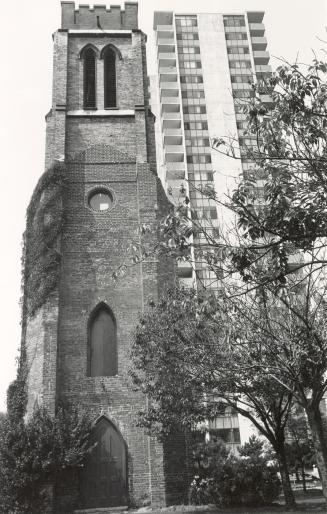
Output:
[24, 2, 185, 513]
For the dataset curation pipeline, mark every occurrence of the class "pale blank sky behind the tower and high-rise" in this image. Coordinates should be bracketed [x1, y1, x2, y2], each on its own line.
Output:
[0, 0, 327, 411]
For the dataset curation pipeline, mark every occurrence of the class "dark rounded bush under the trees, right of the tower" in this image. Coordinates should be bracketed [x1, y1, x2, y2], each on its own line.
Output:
[190, 438, 280, 507]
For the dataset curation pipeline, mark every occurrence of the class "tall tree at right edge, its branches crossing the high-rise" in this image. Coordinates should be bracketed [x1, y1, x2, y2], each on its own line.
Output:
[129, 59, 327, 498]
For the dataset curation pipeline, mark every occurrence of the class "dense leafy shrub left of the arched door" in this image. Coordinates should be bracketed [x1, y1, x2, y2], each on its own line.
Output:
[0, 408, 91, 514]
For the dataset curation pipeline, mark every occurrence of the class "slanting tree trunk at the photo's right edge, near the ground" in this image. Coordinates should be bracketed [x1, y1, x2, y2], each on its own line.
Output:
[306, 405, 327, 503]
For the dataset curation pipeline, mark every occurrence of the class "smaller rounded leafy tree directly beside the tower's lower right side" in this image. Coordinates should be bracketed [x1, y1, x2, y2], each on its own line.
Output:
[131, 288, 295, 506]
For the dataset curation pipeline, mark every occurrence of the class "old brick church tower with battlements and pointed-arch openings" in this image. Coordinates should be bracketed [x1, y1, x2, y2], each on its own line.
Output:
[23, 2, 186, 512]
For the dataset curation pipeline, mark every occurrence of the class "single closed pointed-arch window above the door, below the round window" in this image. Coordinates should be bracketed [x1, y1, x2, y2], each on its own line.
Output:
[88, 304, 118, 377]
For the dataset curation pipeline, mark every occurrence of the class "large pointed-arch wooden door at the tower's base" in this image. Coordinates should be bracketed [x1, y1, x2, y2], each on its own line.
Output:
[81, 418, 127, 508]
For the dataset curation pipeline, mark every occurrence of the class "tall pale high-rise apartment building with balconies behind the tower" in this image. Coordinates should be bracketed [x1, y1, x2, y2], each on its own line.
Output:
[151, 12, 271, 444]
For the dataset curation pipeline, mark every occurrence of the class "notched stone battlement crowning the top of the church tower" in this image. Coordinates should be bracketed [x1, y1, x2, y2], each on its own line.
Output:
[61, 1, 138, 30]
